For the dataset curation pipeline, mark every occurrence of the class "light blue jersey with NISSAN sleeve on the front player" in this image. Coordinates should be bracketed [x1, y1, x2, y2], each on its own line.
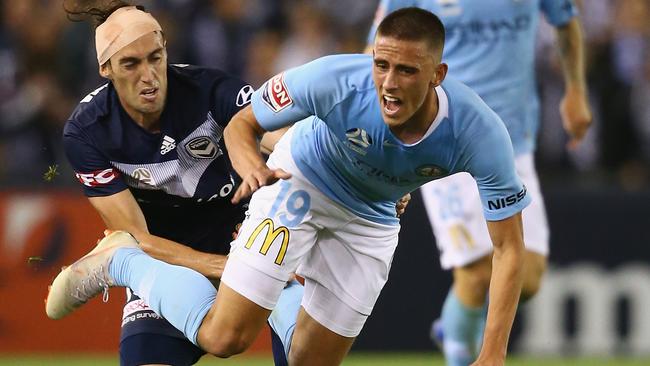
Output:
[252, 55, 530, 225]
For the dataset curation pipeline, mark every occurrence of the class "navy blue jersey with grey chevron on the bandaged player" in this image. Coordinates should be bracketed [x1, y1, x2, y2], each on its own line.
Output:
[63, 65, 253, 253]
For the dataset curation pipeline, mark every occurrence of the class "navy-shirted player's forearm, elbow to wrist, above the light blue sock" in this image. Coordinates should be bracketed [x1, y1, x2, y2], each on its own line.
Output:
[134, 233, 227, 279]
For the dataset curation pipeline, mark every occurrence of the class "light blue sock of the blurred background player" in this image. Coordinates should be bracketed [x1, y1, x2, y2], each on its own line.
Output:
[441, 288, 485, 366]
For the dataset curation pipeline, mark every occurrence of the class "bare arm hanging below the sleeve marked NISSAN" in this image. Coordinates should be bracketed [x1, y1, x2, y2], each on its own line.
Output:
[473, 213, 524, 365]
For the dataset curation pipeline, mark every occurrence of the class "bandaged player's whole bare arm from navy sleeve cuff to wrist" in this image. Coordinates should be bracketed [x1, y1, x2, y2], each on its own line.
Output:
[88, 189, 226, 279]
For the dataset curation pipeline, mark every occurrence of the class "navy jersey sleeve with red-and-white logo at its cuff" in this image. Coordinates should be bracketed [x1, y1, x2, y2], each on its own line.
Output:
[63, 127, 128, 197]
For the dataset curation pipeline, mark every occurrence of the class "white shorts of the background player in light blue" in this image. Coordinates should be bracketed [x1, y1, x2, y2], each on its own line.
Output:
[420, 154, 549, 269]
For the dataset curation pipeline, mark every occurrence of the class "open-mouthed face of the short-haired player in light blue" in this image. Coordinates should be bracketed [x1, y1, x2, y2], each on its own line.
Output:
[372, 36, 446, 127]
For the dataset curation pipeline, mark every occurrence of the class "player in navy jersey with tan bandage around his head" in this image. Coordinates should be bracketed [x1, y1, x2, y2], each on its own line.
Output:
[58, 1, 292, 365]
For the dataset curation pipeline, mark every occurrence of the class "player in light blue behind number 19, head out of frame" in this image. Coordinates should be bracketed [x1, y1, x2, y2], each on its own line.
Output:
[368, 0, 591, 366]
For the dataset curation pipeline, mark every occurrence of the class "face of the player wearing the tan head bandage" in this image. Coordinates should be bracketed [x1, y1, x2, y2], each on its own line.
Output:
[100, 32, 167, 120]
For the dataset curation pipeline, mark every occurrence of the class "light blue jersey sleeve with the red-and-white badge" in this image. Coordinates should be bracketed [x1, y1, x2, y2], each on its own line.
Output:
[251, 56, 344, 131]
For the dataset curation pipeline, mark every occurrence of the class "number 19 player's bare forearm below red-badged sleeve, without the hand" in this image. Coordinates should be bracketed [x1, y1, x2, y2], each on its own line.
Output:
[224, 108, 266, 177]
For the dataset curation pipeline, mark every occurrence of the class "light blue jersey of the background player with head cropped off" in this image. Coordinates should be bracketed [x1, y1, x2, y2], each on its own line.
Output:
[368, 0, 577, 155]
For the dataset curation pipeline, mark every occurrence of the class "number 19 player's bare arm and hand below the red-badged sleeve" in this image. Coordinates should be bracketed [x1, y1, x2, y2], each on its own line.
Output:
[223, 105, 291, 204]
